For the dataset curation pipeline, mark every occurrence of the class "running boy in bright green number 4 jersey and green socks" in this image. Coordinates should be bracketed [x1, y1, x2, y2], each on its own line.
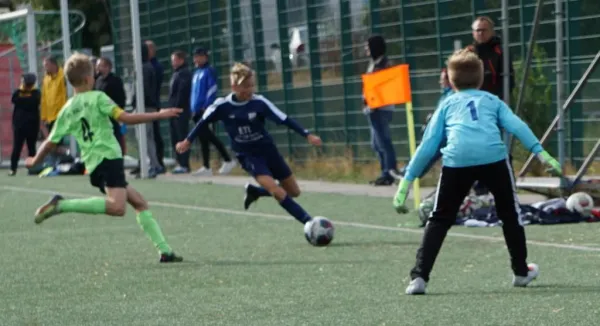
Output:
[26, 53, 183, 263]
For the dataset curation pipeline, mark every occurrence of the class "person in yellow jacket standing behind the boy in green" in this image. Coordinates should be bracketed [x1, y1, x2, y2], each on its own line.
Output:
[41, 57, 67, 138]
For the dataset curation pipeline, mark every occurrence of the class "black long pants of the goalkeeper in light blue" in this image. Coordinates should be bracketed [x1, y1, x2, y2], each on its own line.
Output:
[410, 160, 528, 282]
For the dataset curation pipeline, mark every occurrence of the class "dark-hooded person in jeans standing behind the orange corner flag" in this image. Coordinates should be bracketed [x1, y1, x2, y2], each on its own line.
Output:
[363, 35, 399, 186]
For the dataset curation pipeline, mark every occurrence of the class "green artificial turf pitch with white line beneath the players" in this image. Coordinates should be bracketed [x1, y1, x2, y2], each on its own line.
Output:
[0, 176, 600, 326]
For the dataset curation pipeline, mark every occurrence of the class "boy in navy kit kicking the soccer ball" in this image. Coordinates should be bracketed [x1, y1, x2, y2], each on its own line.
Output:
[176, 63, 321, 238]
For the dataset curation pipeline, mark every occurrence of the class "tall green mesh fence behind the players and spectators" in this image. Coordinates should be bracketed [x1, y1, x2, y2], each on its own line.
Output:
[116, 0, 600, 165]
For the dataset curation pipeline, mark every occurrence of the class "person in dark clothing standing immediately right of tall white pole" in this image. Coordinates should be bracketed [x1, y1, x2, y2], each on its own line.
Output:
[132, 44, 164, 178]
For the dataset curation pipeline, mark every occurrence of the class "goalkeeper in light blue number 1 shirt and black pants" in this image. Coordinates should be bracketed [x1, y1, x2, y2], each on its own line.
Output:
[394, 50, 562, 294]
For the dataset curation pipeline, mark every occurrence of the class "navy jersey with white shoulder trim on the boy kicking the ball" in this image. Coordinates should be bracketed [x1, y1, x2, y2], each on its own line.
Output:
[187, 93, 308, 153]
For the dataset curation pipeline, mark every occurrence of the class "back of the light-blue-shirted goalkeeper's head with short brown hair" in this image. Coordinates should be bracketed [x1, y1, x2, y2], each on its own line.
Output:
[447, 49, 483, 90]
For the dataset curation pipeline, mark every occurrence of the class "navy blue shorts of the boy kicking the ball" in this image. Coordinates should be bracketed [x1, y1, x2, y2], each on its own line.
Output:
[236, 150, 292, 181]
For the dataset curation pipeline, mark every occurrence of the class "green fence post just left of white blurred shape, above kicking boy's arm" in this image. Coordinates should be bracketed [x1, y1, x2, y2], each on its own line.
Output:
[277, 0, 294, 155]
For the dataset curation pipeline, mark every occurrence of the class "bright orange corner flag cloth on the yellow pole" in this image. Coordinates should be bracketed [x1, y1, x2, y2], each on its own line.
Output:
[362, 64, 412, 109]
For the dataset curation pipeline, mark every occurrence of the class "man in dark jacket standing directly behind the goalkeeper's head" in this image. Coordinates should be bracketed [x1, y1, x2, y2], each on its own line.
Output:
[469, 16, 515, 100]
